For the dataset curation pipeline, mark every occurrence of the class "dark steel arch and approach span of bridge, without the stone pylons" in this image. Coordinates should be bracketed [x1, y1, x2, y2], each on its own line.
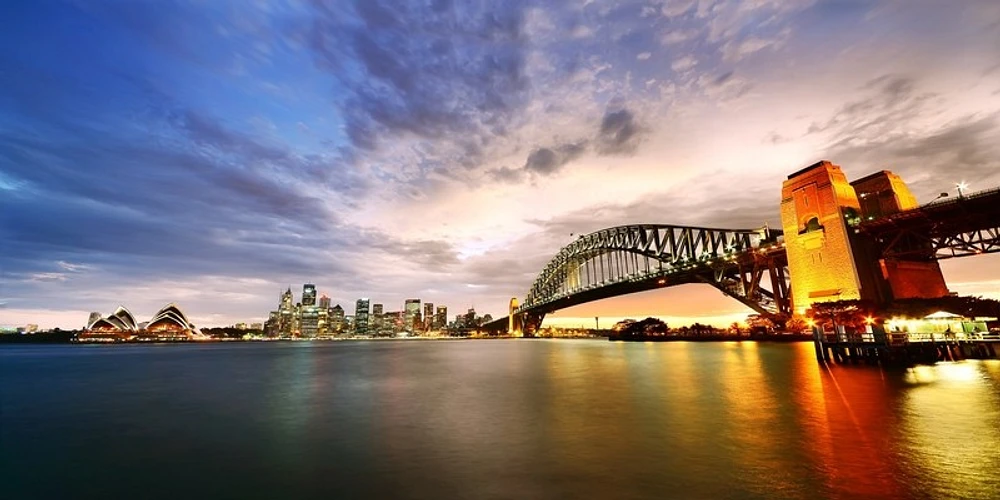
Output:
[483, 188, 1000, 333]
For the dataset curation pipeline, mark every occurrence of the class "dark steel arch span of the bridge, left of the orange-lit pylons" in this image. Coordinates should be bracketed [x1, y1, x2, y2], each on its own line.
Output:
[516, 225, 789, 326]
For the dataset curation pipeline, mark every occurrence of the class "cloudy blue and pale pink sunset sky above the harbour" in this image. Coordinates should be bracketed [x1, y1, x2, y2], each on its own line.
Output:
[0, 0, 1000, 328]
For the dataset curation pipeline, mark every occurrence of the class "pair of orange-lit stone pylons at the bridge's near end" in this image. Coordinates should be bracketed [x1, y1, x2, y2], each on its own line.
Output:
[781, 161, 948, 315]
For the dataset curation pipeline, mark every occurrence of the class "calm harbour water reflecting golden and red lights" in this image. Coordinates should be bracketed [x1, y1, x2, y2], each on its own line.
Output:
[0, 340, 1000, 499]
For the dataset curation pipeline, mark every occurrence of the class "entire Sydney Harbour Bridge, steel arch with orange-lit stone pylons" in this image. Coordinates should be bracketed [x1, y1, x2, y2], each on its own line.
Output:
[485, 161, 1000, 336]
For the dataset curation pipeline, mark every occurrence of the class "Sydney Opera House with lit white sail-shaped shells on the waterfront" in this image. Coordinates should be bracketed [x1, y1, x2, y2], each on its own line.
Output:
[77, 303, 205, 342]
